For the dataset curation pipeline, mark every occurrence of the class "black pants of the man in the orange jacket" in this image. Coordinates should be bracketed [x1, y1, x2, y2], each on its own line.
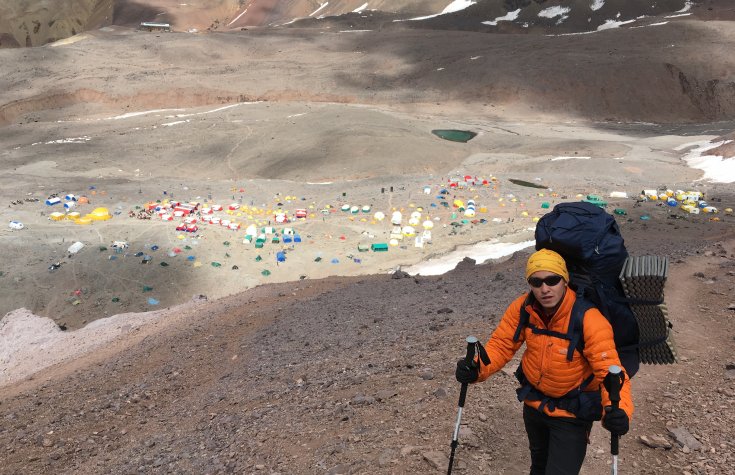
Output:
[523, 404, 592, 475]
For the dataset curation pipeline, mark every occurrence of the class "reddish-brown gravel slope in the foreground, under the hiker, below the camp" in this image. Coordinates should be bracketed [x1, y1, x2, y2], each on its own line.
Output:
[0, 200, 735, 474]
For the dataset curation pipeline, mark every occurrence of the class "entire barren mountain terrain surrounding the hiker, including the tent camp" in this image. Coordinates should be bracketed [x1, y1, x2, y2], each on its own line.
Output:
[0, 0, 735, 475]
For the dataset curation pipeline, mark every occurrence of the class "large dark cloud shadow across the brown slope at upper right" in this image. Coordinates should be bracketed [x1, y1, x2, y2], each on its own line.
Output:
[326, 17, 735, 122]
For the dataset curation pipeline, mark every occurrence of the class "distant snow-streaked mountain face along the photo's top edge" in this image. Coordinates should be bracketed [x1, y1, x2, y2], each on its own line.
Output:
[0, 0, 704, 48]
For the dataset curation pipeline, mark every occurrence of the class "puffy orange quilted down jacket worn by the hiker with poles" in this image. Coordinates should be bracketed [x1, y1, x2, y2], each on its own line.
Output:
[478, 291, 633, 418]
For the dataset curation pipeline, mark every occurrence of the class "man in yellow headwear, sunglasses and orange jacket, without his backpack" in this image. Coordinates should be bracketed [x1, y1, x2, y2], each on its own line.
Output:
[456, 249, 633, 475]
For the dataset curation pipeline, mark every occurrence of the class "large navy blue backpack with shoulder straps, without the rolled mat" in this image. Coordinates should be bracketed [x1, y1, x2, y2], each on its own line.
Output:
[515, 202, 644, 377]
